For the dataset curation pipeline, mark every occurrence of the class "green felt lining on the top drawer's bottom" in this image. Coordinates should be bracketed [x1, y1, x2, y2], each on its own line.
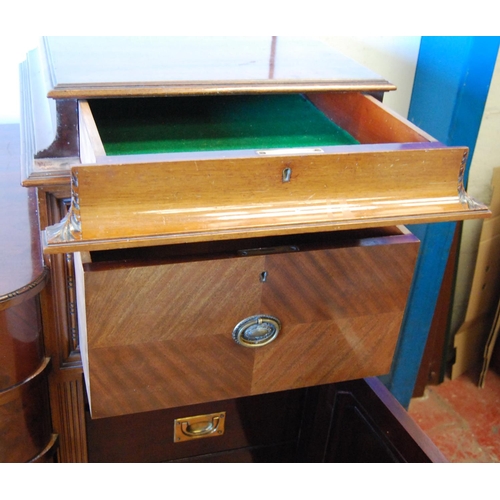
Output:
[90, 94, 359, 156]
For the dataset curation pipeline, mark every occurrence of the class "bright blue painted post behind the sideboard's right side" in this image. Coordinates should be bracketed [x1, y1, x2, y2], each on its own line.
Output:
[381, 37, 500, 408]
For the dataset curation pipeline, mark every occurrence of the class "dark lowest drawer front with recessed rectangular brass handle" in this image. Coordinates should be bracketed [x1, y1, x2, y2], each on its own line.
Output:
[87, 389, 306, 463]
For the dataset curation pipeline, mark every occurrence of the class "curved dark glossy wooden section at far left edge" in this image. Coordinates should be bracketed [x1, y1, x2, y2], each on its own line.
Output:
[0, 126, 57, 462]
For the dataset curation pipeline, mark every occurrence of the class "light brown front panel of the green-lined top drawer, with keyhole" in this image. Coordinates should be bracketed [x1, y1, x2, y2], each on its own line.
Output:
[68, 146, 468, 248]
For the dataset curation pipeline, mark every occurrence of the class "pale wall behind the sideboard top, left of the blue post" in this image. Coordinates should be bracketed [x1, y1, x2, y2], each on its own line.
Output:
[0, 35, 420, 123]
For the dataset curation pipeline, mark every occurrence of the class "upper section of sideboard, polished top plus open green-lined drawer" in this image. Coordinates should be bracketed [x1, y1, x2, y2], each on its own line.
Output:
[17, 37, 489, 253]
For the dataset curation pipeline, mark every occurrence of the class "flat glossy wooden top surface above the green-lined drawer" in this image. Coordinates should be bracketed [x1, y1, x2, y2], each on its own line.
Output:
[43, 36, 395, 98]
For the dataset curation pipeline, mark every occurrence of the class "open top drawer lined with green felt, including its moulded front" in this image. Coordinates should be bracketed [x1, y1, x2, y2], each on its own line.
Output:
[44, 92, 488, 253]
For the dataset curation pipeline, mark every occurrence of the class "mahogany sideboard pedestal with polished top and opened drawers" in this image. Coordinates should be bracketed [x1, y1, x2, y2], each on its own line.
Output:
[0, 37, 488, 462]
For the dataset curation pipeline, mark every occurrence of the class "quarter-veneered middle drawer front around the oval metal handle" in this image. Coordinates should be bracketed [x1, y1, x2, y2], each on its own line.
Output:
[77, 229, 418, 418]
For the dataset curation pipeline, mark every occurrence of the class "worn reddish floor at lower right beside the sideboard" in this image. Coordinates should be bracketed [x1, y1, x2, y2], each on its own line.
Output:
[408, 370, 500, 463]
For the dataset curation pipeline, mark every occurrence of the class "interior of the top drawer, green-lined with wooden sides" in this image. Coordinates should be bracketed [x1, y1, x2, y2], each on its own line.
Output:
[80, 92, 434, 156]
